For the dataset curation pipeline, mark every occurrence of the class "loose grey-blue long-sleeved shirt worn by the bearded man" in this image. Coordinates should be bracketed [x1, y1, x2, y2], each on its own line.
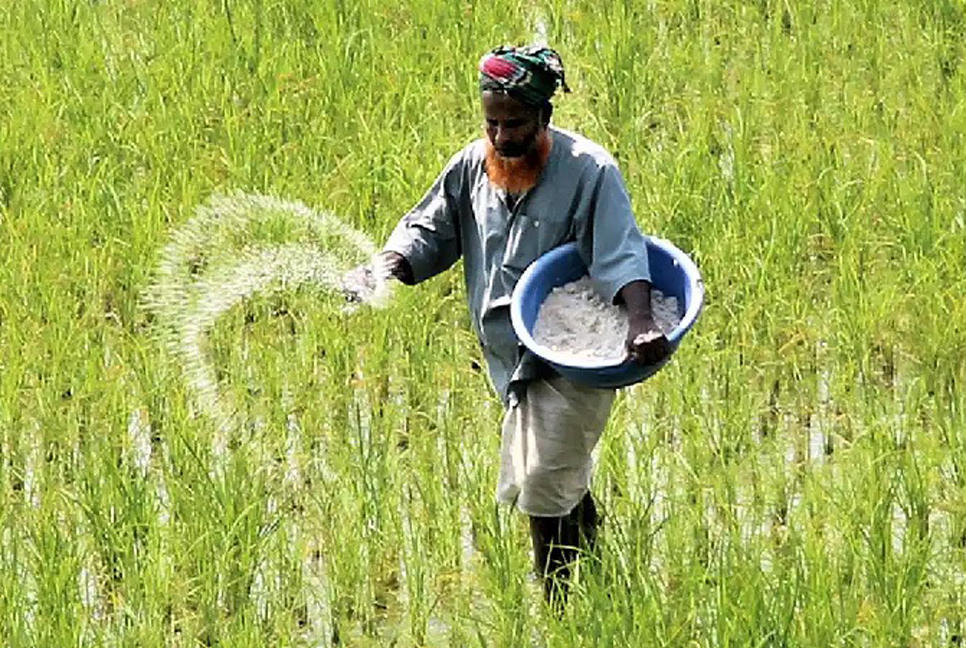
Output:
[385, 127, 650, 402]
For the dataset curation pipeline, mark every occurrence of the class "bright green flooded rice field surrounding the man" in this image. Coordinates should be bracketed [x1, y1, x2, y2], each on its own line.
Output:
[0, 0, 966, 646]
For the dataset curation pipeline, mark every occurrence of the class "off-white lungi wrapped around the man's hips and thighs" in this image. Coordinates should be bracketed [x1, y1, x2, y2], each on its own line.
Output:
[496, 376, 616, 517]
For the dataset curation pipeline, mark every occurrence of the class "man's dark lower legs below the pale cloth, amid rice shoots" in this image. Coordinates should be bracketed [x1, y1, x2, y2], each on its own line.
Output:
[530, 491, 600, 605]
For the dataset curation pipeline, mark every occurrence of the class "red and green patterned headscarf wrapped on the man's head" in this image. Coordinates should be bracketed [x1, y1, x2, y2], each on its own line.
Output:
[480, 45, 570, 106]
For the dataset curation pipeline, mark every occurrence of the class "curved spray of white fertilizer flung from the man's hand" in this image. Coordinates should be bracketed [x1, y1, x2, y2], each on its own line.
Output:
[144, 193, 390, 457]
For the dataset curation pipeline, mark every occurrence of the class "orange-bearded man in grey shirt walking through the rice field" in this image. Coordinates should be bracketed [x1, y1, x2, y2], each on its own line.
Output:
[379, 46, 669, 601]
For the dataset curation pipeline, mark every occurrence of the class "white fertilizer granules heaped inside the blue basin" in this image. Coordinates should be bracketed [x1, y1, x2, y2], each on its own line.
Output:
[533, 276, 681, 365]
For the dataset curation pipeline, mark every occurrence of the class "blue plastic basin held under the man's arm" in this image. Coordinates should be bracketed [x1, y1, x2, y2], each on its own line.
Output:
[510, 236, 704, 388]
